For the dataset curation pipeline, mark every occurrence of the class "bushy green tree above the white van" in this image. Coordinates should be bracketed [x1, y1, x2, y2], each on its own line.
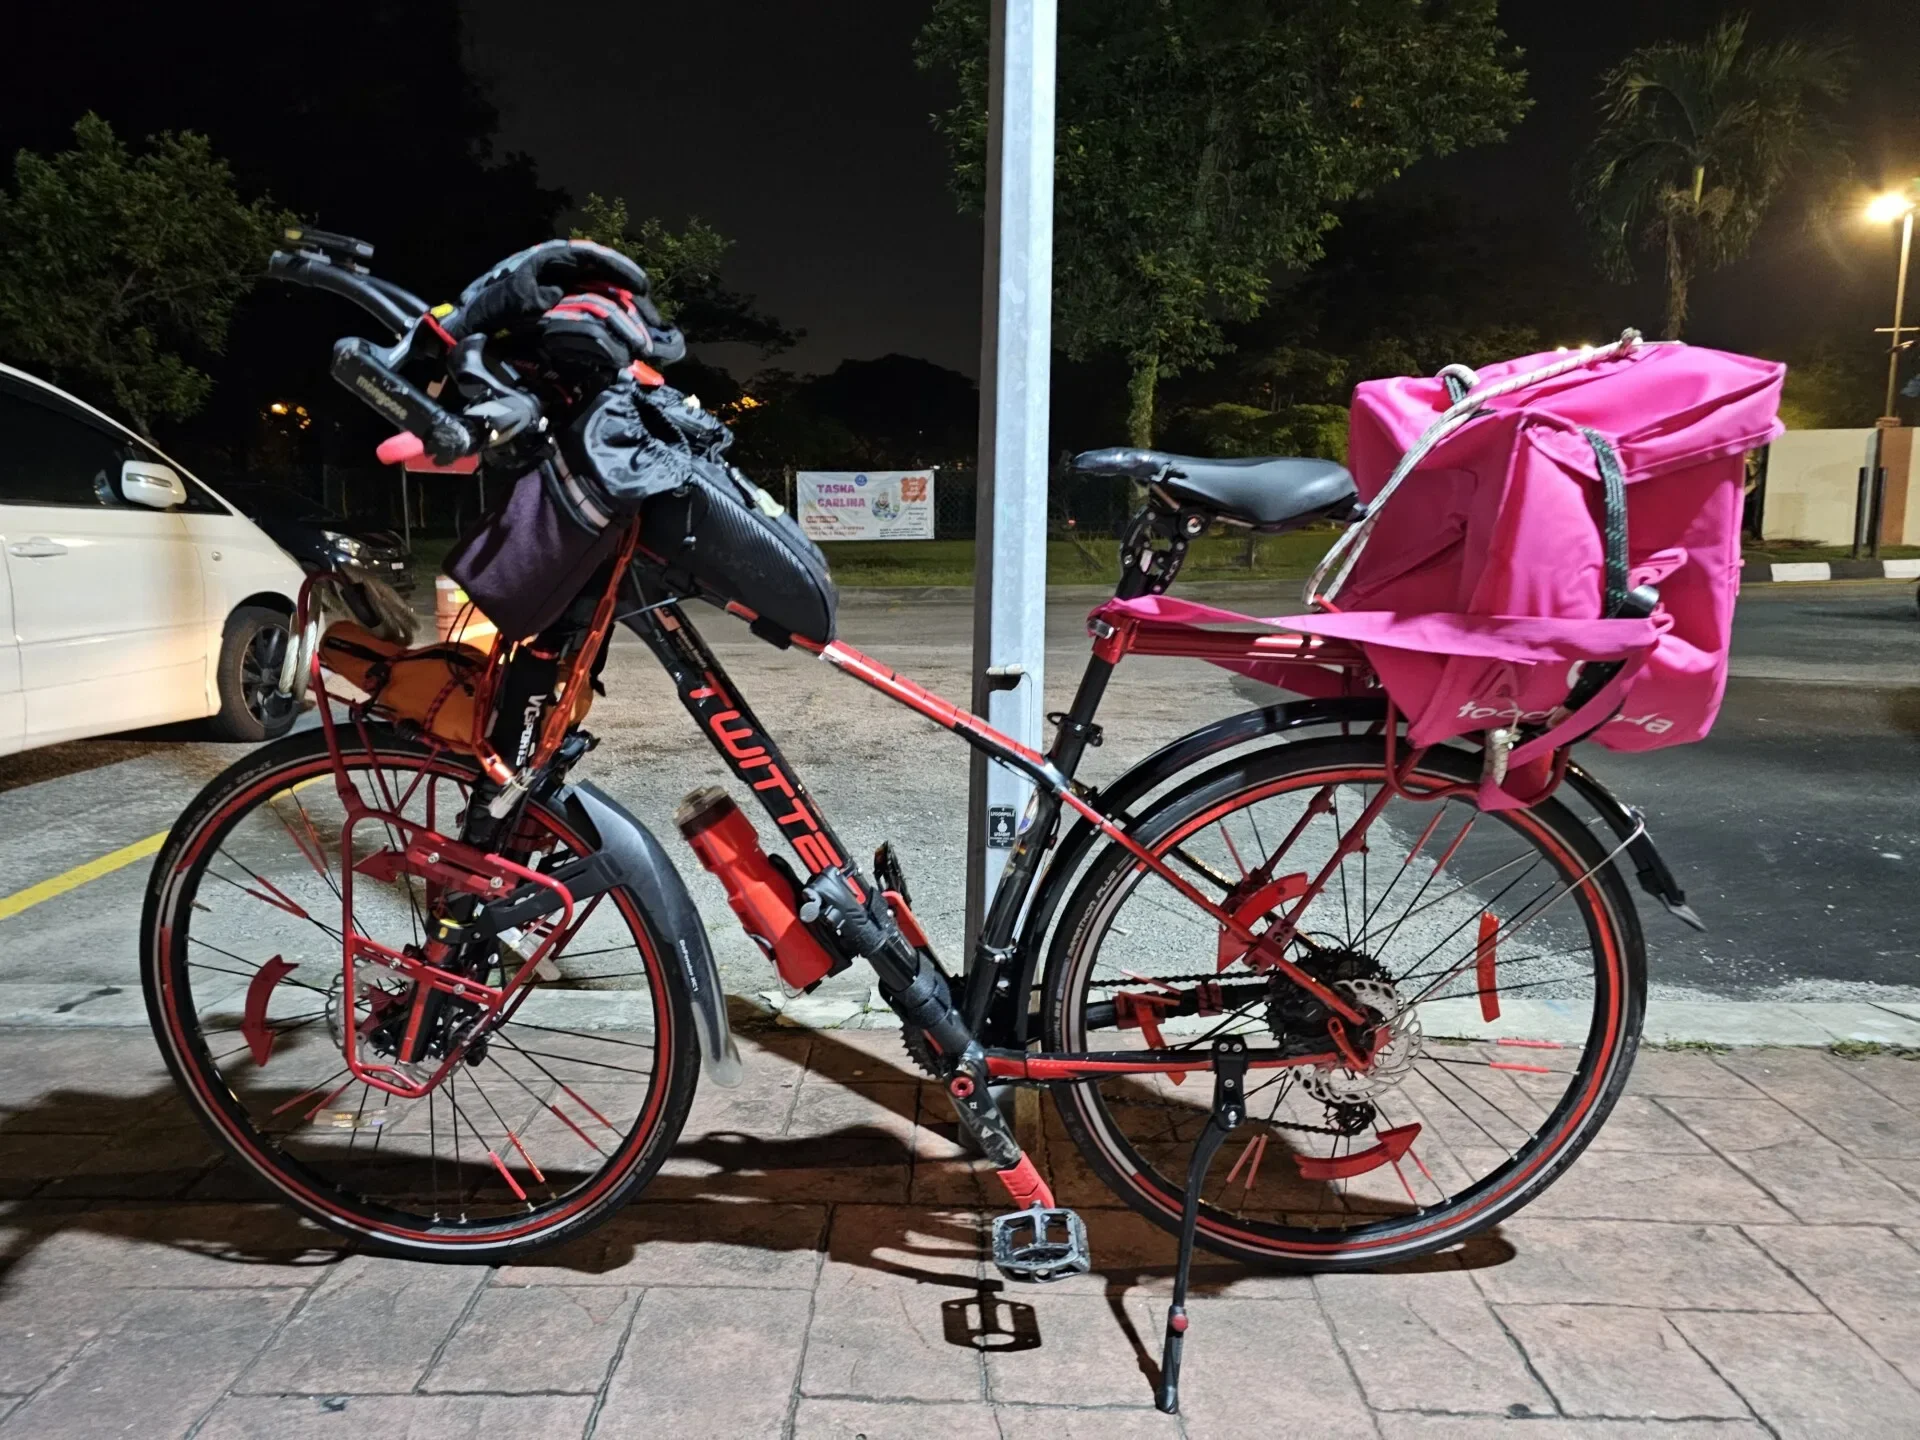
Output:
[0, 115, 292, 434]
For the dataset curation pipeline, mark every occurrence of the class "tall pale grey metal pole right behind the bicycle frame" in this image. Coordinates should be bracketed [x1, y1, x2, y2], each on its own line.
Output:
[966, 0, 1058, 964]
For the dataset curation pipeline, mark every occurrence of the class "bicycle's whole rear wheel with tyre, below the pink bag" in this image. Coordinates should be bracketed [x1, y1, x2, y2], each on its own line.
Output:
[1043, 737, 1645, 1269]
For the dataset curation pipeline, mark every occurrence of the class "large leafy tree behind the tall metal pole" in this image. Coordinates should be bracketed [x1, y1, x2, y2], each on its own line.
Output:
[918, 0, 1526, 444]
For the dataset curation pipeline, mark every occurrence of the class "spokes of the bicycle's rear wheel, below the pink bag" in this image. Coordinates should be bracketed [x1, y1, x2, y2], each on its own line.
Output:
[1056, 741, 1635, 1254]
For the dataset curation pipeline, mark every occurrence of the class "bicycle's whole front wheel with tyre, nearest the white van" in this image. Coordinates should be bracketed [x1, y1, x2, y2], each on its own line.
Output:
[140, 726, 699, 1263]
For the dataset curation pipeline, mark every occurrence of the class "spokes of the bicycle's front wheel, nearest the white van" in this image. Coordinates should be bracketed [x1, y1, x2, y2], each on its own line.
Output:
[151, 749, 684, 1235]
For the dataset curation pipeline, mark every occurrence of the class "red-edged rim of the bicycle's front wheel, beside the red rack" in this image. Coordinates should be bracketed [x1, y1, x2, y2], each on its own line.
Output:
[157, 755, 674, 1244]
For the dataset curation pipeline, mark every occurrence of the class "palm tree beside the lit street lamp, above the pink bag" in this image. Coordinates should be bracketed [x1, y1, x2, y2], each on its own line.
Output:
[1574, 15, 1851, 340]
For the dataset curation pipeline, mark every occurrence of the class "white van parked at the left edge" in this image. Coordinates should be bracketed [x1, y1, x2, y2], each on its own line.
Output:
[0, 365, 303, 755]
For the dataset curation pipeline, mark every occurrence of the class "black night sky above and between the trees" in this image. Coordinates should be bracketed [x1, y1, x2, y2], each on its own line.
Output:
[0, 0, 1920, 395]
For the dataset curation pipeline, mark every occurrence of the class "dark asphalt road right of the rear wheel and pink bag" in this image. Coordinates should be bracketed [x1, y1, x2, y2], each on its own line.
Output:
[1580, 584, 1920, 998]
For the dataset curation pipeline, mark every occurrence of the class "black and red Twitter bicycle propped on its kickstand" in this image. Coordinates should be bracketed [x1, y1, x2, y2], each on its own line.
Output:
[140, 231, 1690, 1411]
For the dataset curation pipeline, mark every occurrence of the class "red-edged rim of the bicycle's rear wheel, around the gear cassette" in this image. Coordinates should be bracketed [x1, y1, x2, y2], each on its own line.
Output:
[1060, 748, 1626, 1256]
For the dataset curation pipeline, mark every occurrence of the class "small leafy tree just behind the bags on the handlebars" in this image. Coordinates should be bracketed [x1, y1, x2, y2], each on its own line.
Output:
[574, 194, 801, 355]
